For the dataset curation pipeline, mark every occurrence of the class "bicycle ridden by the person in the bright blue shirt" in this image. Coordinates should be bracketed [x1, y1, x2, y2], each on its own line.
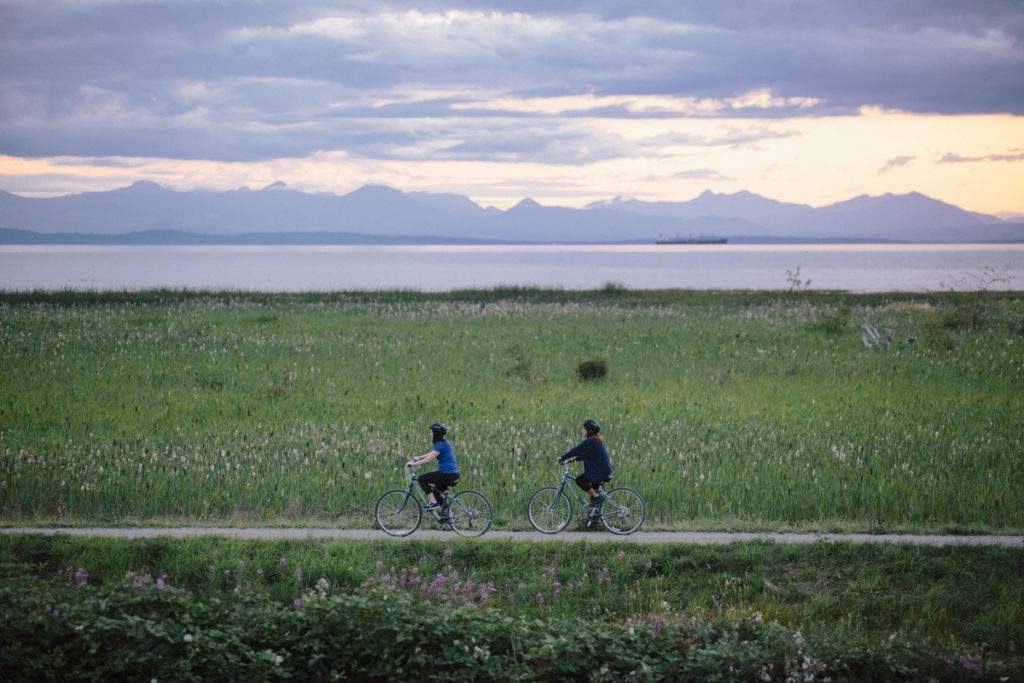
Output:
[374, 465, 495, 537]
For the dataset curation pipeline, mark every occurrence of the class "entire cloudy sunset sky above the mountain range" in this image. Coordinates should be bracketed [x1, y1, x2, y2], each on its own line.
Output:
[0, 0, 1024, 214]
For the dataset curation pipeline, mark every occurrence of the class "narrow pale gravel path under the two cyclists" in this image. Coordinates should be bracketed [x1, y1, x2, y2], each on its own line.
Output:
[0, 526, 1024, 548]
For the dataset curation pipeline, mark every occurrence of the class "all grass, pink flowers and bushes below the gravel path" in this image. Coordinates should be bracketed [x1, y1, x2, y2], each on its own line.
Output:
[0, 536, 1024, 680]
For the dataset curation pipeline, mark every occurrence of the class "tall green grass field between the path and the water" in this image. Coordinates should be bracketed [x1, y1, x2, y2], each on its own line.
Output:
[0, 288, 1024, 531]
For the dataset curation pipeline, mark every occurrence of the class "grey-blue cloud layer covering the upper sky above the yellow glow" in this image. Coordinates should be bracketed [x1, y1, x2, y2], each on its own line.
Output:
[0, 0, 1024, 163]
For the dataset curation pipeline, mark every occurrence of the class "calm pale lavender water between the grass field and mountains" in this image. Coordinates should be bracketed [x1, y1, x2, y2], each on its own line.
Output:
[0, 244, 1024, 292]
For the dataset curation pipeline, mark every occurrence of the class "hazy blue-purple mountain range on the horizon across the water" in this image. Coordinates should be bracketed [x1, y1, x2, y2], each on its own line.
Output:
[0, 180, 1024, 244]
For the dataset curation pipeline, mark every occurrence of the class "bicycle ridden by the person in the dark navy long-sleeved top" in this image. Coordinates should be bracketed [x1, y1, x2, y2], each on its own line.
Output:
[526, 463, 646, 536]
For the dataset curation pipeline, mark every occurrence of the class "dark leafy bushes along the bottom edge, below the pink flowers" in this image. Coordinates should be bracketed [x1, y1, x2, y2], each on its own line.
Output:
[6, 579, 1024, 681]
